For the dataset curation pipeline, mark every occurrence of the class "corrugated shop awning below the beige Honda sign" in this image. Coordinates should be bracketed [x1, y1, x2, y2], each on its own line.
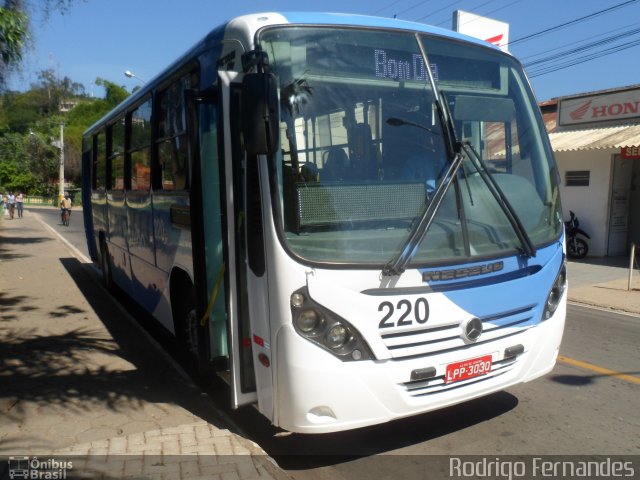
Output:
[549, 125, 640, 152]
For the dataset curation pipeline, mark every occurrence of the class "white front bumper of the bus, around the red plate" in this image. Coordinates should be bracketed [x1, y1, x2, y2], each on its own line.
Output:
[273, 300, 566, 433]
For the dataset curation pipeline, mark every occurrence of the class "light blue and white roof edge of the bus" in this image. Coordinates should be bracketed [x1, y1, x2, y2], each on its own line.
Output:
[83, 12, 497, 135]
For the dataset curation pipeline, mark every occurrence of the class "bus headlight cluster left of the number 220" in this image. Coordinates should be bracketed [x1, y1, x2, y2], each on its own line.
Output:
[291, 287, 374, 361]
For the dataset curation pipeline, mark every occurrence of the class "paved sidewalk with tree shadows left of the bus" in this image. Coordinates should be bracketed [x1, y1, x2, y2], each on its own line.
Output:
[0, 211, 289, 480]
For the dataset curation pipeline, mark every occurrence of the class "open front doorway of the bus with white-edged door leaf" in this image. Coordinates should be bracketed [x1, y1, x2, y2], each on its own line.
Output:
[194, 64, 257, 408]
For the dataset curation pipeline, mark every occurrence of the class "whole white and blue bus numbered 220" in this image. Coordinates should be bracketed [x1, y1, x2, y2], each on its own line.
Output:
[83, 13, 566, 433]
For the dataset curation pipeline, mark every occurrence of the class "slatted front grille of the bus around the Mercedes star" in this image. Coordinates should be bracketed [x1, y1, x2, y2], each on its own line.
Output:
[381, 305, 538, 360]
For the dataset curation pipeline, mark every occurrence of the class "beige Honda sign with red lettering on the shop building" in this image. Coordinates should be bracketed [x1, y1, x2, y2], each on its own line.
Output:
[558, 89, 640, 125]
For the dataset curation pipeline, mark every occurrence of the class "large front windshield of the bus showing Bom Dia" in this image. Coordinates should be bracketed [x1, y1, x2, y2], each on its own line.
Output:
[259, 27, 562, 267]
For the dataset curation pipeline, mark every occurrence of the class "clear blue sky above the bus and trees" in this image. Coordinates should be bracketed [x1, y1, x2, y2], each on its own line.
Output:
[9, 0, 640, 101]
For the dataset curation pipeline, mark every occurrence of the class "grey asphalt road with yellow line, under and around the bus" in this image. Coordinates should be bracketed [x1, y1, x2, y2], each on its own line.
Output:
[28, 209, 640, 479]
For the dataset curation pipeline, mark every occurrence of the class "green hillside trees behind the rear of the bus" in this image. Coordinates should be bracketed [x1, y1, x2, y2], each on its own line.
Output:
[0, 71, 129, 195]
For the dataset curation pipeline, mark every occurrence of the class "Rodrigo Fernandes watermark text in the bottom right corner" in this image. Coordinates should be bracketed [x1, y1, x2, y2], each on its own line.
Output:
[449, 456, 640, 480]
